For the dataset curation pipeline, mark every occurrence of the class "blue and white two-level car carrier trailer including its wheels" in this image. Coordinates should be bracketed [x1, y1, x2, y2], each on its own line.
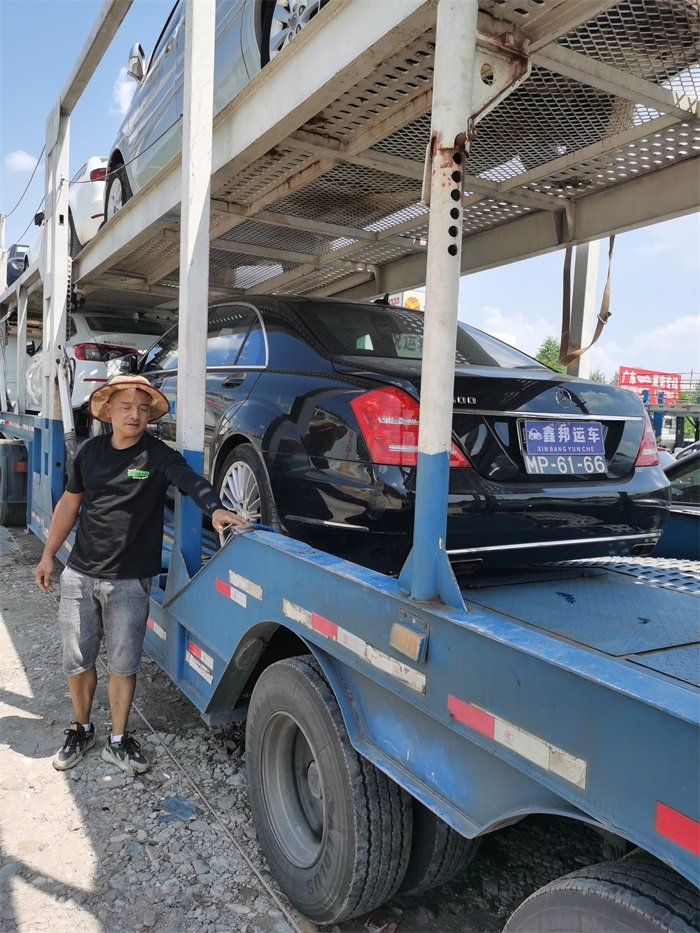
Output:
[0, 0, 700, 931]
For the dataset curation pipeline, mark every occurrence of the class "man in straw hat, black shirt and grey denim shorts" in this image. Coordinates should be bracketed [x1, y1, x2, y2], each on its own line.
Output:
[34, 376, 244, 773]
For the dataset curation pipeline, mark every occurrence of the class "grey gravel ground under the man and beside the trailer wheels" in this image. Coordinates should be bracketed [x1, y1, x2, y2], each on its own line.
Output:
[0, 528, 608, 933]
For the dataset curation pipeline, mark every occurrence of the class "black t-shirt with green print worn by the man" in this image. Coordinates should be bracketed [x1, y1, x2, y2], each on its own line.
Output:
[66, 434, 223, 580]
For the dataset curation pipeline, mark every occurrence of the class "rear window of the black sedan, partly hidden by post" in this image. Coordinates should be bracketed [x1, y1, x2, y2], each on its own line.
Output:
[303, 305, 546, 369]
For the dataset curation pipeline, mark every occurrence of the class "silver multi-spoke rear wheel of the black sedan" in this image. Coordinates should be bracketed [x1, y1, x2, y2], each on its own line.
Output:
[216, 444, 279, 529]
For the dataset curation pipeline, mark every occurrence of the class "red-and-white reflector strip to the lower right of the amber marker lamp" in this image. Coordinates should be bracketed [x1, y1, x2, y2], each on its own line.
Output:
[447, 694, 587, 789]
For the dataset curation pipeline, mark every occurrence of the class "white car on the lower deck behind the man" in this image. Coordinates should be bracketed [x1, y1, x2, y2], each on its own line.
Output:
[25, 311, 166, 429]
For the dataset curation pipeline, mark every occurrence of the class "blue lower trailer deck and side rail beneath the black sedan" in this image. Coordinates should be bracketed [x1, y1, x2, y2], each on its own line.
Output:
[142, 530, 700, 883]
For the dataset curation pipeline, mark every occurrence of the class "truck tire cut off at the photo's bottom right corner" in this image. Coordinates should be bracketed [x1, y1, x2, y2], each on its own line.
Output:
[503, 852, 700, 933]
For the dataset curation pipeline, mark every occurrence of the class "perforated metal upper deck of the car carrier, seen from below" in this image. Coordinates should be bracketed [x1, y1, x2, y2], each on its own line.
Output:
[0, 0, 700, 315]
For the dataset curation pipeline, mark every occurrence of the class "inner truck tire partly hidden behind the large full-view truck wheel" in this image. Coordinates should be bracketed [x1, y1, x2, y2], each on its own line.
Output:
[398, 799, 481, 895]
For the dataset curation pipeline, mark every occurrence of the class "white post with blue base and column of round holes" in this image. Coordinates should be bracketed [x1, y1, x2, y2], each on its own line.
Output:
[401, 0, 479, 604]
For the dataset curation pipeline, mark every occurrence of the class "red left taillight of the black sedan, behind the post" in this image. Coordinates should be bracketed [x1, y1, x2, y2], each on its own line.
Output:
[350, 386, 471, 467]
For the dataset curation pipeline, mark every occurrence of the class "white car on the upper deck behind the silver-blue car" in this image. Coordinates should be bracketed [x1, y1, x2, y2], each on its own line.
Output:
[24, 156, 107, 269]
